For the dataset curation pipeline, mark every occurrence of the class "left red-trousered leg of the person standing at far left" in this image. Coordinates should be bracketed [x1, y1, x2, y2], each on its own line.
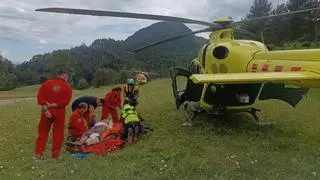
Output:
[35, 113, 51, 158]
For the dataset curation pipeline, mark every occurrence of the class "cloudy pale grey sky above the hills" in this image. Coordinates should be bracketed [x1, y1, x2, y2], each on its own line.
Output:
[0, 0, 284, 64]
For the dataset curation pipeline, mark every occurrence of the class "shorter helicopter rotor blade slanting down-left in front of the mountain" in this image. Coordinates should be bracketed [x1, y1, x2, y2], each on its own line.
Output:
[133, 26, 215, 52]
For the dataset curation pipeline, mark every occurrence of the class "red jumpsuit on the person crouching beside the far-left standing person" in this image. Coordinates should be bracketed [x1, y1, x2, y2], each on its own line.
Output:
[68, 110, 89, 138]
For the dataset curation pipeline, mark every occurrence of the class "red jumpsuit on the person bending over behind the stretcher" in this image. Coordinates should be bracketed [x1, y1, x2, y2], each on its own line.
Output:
[101, 91, 121, 123]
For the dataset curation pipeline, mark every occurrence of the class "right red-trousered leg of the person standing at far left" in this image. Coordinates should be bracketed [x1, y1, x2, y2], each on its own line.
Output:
[51, 111, 65, 159]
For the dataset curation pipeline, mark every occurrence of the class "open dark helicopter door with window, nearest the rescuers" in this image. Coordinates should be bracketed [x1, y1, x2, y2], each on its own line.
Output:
[170, 68, 203, 109]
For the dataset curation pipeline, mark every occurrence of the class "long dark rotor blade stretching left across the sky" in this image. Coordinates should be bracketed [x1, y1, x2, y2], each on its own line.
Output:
[36, 8, 216, 26]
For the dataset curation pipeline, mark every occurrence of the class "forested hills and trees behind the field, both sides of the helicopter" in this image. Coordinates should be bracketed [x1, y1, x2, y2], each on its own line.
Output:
[0, 0, 320, 90]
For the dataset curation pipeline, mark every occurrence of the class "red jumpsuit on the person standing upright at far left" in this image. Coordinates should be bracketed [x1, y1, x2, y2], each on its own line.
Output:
[35, 77, 72, 158]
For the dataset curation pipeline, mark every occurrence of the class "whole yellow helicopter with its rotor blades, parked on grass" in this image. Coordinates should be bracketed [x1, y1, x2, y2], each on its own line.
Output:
[36, 8, 320, 125]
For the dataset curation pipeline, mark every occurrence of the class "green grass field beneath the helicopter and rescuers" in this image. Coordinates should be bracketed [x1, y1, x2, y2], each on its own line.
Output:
[0, 80, 320, 180]
